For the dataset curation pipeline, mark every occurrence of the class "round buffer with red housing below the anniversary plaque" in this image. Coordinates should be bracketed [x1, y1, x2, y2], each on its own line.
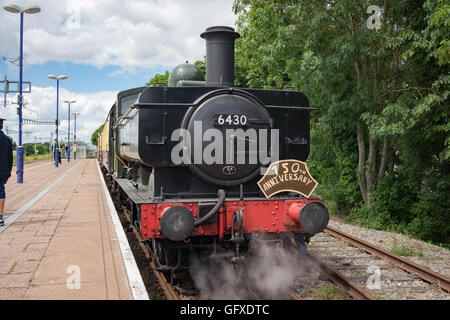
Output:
[288, 201, 330, 234]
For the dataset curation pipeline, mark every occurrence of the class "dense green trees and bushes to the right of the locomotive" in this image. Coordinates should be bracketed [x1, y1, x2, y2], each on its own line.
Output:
[233, 0, 450, 243]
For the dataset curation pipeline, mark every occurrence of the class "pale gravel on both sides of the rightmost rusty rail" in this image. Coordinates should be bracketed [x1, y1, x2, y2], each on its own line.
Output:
[308, 221, 450, 300]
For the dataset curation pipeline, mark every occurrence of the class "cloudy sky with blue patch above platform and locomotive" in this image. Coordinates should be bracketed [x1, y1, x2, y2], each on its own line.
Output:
[0, 0, 236, 143]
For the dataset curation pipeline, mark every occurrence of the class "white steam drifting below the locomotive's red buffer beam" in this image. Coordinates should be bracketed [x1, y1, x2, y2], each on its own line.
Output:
[190, 241, 310, 300]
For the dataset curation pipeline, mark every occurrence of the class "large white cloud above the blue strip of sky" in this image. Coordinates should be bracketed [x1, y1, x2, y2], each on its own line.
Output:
[0, 0, 235, 70]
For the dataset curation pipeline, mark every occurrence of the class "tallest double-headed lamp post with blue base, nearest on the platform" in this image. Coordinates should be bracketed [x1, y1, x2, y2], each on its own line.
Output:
[3, 4, 41, 183]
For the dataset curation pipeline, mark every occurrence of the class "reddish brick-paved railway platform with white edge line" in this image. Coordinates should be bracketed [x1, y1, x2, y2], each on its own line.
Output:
[0, 159, 148, 300]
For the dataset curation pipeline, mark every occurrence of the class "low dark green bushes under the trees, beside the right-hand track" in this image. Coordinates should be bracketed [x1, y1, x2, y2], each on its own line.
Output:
[347, 173, 450, 247]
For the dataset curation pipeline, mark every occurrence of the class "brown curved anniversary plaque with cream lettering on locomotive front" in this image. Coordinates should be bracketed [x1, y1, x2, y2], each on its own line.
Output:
[258, 159, 318, 198]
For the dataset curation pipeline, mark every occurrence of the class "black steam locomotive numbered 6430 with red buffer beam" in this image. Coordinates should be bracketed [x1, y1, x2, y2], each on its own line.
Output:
[98, 26, 329, 274]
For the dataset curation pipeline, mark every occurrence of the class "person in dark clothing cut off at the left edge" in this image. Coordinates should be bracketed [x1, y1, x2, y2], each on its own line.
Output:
[0, 118, 12, 226]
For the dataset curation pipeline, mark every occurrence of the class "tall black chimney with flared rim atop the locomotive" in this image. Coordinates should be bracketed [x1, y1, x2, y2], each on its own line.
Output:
[200, 26, 240, 87]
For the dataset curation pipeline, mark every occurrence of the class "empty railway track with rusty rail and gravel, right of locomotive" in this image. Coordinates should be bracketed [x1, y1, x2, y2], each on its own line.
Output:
[308, 227, 450, 299]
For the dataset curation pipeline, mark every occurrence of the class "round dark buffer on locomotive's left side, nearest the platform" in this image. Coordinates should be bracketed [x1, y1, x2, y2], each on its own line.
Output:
[161, 206, 194, 241]
